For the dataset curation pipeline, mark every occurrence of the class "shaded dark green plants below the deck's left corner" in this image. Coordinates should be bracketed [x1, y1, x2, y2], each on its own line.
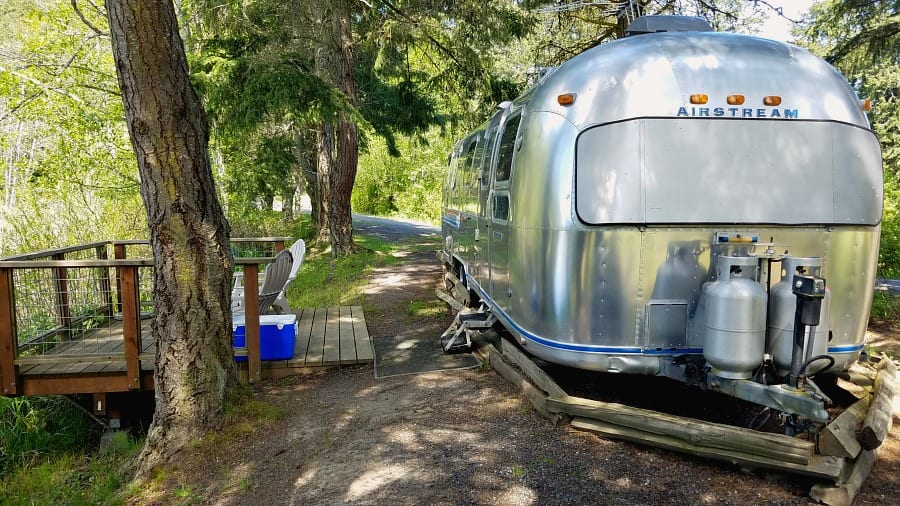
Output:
[0, 397, 98, 474]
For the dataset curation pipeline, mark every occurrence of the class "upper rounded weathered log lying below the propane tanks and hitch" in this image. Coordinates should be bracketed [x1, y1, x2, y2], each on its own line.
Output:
[547, 396, 814, 466]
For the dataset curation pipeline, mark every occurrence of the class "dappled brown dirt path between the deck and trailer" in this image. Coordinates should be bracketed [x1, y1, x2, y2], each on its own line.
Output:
[144, 226, 900, 505]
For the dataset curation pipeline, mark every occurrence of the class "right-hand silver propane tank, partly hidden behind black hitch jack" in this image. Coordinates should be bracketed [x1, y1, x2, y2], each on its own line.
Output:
[766, 257, 831, 376]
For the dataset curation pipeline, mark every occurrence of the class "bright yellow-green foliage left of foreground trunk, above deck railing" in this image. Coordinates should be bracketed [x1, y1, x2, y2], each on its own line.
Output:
[0, 0, 146, 255]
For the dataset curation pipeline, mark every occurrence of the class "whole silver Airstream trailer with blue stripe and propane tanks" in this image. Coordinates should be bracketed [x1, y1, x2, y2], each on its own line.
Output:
[441, 17, 882, 422]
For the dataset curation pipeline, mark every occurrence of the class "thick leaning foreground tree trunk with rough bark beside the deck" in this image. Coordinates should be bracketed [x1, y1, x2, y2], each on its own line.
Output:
[106, 0, 237, 477]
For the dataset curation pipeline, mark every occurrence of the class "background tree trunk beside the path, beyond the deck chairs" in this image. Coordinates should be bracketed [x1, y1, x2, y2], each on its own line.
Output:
[314, 0, 359, 257]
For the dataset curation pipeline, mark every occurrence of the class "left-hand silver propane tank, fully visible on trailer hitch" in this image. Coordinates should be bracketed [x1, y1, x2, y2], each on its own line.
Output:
[703, 256, 766, 379]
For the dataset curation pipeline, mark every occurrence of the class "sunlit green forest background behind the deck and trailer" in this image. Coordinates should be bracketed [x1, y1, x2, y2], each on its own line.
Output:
[0, 0, 900, 266]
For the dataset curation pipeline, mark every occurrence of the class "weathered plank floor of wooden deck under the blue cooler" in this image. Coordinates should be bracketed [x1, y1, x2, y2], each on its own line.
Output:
[15, 306, 374, 395]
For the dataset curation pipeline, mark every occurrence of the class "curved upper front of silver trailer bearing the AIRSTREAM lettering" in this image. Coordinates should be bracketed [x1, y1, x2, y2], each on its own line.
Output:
[528, 33, 869, 129]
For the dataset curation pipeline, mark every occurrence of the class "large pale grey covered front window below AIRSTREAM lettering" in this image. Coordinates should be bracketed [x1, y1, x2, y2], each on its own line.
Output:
[575, 118, 883, 225]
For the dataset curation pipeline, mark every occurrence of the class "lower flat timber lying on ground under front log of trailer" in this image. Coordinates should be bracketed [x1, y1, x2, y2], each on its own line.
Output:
[572, 417, 844, 481]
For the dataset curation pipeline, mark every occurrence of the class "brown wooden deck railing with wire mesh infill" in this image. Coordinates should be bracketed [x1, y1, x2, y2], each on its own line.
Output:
[0, 237, 288, 395]
